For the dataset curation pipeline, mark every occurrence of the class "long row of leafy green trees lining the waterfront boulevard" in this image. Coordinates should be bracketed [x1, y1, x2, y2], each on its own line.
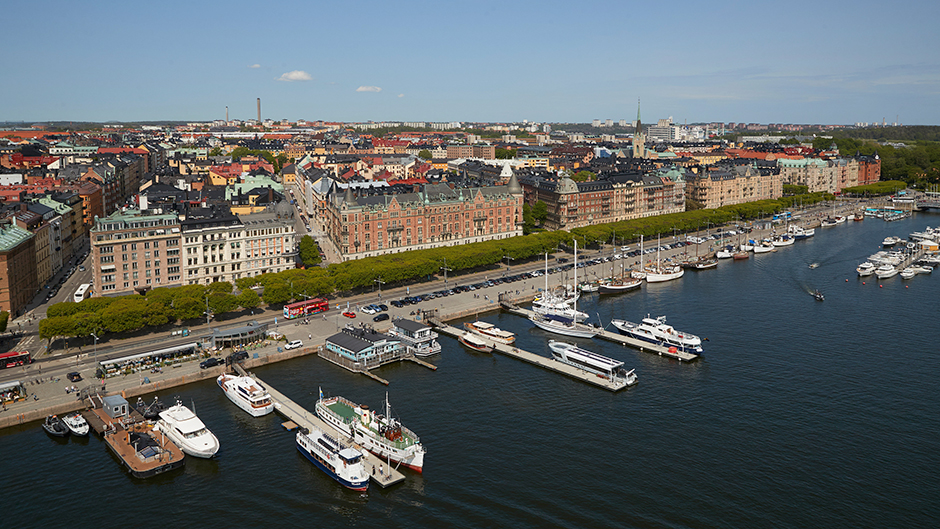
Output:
[39, 193, 834, 342]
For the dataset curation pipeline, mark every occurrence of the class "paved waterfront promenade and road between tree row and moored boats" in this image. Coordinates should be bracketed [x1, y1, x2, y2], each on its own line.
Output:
[0, 200, 864, 428]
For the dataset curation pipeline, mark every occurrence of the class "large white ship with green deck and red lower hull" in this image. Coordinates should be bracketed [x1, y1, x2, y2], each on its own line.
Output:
[316, 391, 427, 472]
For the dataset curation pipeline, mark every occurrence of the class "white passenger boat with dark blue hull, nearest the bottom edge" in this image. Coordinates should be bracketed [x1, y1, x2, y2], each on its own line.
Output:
[296, 426, 369, 492]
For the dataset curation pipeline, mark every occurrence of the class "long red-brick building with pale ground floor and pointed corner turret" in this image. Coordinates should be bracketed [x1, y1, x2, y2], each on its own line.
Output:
[326, 175, 523, 260]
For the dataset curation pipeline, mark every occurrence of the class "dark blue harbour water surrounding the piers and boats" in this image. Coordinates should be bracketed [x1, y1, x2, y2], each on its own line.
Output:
[0, 214, 940, 528]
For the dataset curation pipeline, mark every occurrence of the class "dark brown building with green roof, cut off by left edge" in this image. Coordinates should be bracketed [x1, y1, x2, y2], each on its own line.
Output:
[0, 223, 39, 318]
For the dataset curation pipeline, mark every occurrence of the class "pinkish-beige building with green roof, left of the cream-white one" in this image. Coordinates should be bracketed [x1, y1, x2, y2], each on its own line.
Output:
[91, 209, 182, 295]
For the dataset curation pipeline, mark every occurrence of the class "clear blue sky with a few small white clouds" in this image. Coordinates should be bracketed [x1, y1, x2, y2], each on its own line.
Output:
[0, 0, 940, 125]
